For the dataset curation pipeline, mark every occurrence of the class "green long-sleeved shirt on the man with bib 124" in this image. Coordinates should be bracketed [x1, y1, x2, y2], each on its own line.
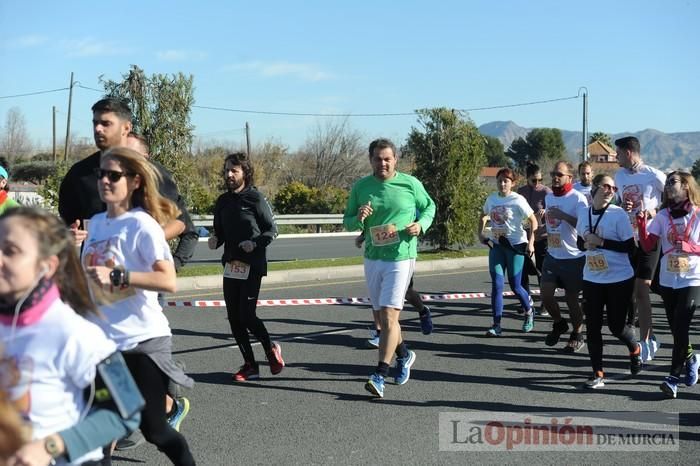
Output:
[343, 172, 435, 262]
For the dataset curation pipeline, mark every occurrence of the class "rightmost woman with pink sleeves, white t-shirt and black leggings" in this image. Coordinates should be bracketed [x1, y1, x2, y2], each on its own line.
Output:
[637, 171, 700, 398]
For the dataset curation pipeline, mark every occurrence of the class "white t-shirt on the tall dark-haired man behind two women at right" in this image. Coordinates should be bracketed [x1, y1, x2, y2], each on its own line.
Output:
[615, 165, 666, 238]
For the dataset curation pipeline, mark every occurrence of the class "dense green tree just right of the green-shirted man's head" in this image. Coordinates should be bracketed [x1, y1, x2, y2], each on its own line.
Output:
[405, 107, 486, 249]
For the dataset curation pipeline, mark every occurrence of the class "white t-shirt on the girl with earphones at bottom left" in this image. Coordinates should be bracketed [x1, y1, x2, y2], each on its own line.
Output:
[0, 287, 117, 464]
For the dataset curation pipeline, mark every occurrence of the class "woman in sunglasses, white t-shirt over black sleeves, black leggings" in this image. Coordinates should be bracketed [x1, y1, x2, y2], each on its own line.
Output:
[576, 174, 642, 389]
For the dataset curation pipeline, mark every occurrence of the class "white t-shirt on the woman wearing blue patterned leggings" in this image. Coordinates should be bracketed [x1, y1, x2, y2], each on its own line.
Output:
[484, 191, 533, 245]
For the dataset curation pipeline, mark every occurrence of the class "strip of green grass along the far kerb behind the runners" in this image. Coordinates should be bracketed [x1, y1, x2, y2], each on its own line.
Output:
[177, 248, 489, 277]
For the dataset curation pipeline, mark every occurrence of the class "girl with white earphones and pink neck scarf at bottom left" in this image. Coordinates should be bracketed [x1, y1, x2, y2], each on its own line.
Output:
[0, 207, 139, 464]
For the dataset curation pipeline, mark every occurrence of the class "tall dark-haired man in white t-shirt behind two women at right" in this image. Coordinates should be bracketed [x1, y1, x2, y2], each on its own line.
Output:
[615, 136, 666, 362]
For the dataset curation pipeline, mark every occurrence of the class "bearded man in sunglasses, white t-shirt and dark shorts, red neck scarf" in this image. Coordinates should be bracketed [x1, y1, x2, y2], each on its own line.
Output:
[542, 160, 588, 353]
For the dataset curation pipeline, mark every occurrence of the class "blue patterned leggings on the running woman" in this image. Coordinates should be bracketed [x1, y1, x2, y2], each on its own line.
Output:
[489, 244, 531, 325]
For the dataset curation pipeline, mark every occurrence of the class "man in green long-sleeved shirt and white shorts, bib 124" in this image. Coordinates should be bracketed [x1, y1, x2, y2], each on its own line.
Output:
[343, 139, 435, 398]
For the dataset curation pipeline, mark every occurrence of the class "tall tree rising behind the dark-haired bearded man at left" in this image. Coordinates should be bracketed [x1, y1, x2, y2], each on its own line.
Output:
[100, 65, 199, 202]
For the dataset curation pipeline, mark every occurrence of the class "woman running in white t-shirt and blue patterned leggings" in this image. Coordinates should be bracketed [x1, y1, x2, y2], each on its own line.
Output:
[478, 168, 537, 337]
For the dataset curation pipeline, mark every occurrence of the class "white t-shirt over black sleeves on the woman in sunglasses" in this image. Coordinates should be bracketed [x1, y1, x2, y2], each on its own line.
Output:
[576, 205, 634, 283]
